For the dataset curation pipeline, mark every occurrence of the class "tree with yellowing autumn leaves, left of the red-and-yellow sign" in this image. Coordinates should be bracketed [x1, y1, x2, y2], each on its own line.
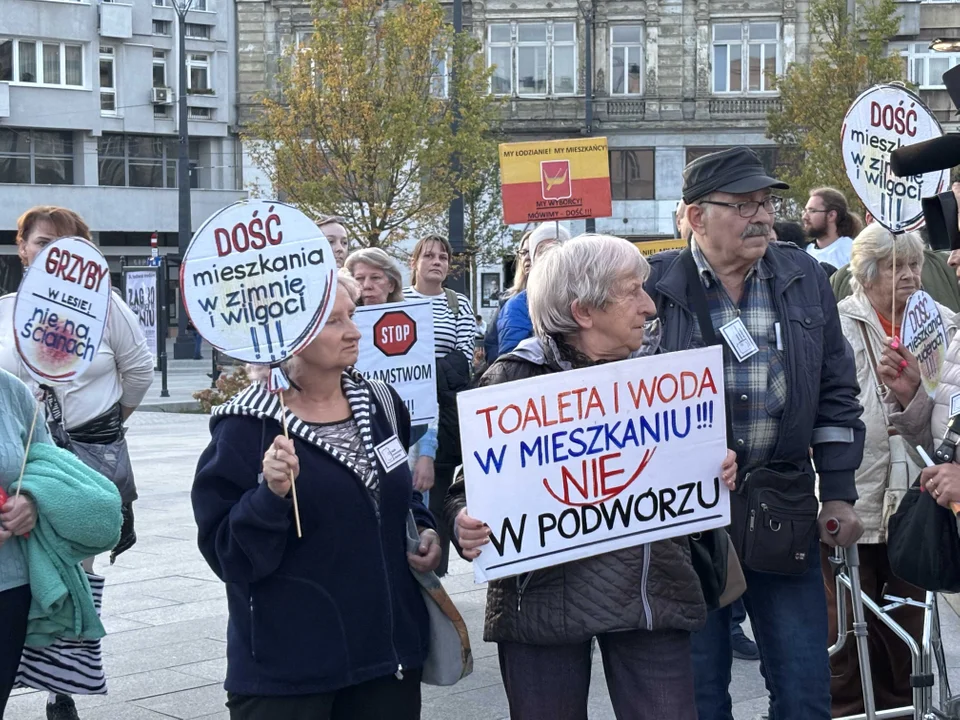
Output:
[247, 0, 499, 247]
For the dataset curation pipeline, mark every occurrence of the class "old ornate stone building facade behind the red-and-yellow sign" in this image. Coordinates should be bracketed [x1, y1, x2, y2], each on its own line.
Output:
[236, 0, 960, 310]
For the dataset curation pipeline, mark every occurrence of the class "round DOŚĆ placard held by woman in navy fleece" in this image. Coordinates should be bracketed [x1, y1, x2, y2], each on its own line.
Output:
[180, 200, 337, 364]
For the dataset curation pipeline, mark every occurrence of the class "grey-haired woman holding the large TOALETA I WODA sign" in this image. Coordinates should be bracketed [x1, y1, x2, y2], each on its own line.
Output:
[446, 235, 736, 720]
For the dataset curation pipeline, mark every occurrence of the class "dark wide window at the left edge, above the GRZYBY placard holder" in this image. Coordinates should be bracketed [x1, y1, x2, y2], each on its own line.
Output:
[0, 128, 73, 185]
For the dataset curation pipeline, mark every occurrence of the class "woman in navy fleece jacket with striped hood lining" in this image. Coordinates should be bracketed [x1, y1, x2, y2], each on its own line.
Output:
[192, 280, 440, 720]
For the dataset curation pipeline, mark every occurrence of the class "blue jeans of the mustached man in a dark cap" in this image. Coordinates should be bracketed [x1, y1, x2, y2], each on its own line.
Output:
[692, 539, 830, 720]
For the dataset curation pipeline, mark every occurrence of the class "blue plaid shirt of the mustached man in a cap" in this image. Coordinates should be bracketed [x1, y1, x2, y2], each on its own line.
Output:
[691, 243, 787, 468]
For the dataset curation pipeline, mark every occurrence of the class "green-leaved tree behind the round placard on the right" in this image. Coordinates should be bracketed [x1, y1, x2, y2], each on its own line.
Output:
[767, 0, 904, 207]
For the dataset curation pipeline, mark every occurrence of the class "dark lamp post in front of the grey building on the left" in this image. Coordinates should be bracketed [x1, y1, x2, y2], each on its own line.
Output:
[172, 0, 194, 360]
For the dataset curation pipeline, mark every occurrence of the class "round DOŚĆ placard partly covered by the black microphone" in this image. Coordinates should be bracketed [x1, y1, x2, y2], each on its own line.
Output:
[841, 85, 949, 233]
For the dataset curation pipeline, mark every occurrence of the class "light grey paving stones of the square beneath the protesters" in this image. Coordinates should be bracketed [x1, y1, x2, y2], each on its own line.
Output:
[5, 410, 960, 720]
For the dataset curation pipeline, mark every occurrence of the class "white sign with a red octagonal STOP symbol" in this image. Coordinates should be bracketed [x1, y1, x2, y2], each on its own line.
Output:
[353, 300, 437, 425]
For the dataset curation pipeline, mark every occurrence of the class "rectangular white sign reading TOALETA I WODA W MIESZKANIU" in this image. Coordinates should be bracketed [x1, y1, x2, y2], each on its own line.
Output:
[457, 346, 730, 582]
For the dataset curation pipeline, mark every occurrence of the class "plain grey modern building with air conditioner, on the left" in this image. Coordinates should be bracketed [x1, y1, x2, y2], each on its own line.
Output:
[0, 0, 246, 291]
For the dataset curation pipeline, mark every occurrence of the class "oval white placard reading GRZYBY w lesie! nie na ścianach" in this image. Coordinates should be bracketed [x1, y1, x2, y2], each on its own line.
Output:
[13, 237, 111, 383]
